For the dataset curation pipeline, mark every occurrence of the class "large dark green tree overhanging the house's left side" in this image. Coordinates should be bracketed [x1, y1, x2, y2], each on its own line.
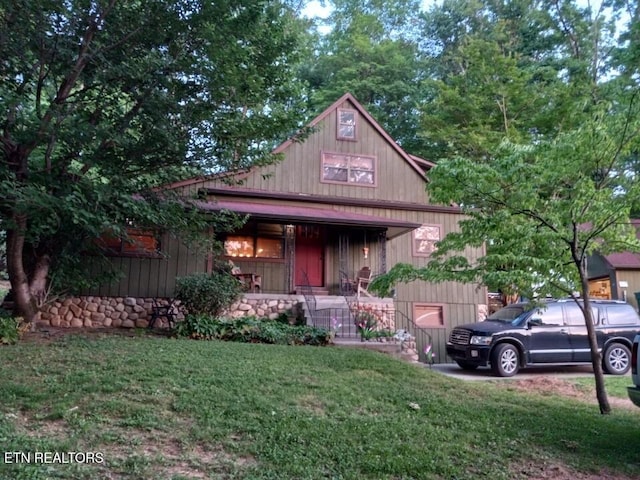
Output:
[0, 0, 308, 320]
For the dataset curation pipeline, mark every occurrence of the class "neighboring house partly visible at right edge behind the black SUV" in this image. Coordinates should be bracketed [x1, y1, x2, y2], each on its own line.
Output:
[587, 219, 640, 309]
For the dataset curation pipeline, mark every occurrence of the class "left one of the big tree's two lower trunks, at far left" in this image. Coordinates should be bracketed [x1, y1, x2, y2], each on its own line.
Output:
[7, 214, 38, 329]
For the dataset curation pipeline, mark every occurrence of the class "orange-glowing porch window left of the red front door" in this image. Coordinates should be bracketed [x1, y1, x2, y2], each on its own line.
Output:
[224, 223, 284, 258]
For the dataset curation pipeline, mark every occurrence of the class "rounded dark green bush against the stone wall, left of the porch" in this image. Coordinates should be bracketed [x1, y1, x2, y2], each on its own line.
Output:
[176, 269, 242, 317]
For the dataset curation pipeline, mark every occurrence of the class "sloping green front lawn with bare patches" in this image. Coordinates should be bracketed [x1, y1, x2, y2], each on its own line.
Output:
[0, 336, 640, 480]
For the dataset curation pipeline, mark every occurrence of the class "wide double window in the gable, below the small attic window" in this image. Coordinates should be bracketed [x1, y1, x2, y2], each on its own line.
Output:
[322, 152, 376, 186]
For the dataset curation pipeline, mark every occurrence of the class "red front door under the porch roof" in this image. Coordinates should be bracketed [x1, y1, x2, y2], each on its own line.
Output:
[295, 225, 324, 287]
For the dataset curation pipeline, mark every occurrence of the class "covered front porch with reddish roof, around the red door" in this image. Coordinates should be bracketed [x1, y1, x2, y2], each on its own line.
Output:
[203, 200, 420, 297]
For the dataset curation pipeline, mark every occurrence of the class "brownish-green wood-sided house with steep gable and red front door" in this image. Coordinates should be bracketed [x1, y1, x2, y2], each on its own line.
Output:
[63, 94, 487, 362]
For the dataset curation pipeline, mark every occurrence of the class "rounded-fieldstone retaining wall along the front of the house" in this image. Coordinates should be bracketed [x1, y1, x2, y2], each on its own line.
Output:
[38, 294, 302, 328]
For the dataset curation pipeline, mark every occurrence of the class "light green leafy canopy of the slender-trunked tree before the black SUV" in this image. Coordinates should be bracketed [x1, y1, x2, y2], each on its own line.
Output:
[372, 96, 640, 298]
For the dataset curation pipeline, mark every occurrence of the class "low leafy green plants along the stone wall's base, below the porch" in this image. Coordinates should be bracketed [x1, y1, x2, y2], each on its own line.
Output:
[176, 315, 332, 345]
